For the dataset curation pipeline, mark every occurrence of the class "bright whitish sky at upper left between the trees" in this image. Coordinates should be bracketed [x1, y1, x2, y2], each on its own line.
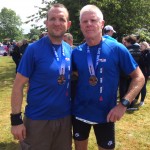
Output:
[0, 0, 43, 33]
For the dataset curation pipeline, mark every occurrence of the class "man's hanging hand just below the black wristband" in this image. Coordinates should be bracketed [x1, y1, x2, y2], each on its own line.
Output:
[11, 124, 26, 141]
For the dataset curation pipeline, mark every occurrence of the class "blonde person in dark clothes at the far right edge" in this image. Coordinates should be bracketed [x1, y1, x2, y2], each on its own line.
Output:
[139, 42, 150, 106]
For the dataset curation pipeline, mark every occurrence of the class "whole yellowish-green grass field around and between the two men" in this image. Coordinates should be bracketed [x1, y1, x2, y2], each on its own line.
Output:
[0, 56, 150, 150]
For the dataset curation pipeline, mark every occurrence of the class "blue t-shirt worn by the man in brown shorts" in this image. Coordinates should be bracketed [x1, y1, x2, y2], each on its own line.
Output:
[18, 36, 72, 120]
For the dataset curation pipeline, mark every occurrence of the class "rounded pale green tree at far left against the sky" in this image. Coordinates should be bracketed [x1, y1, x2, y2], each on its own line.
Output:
[0, 8, 23, 40]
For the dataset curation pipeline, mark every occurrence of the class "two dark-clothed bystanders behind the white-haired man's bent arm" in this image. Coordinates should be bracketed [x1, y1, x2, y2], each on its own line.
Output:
[120, 35, 150, 110]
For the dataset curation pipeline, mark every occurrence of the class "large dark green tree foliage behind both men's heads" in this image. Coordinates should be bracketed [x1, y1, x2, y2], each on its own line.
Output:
[27, 0, 150, 43]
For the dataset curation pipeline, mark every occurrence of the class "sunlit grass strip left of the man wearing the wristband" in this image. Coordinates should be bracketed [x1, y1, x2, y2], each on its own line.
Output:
[0, 56, 17, 150]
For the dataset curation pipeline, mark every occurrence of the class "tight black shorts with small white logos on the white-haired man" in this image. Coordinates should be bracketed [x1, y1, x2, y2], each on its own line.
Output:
[72, 117, 115, 149]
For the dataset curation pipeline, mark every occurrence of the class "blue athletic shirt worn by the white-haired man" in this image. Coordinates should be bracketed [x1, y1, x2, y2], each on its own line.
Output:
[72, 39, 138, 123]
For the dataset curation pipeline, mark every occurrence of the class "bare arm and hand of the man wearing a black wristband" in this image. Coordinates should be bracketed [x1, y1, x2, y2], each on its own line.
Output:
[11, 73, 28, 141]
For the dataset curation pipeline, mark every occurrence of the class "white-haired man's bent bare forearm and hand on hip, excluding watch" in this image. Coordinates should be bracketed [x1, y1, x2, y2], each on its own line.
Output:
[107, 67, 145, 122]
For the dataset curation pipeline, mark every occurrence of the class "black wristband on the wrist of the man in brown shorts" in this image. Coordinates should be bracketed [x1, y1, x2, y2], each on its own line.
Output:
[10, 112, 23, 126]
